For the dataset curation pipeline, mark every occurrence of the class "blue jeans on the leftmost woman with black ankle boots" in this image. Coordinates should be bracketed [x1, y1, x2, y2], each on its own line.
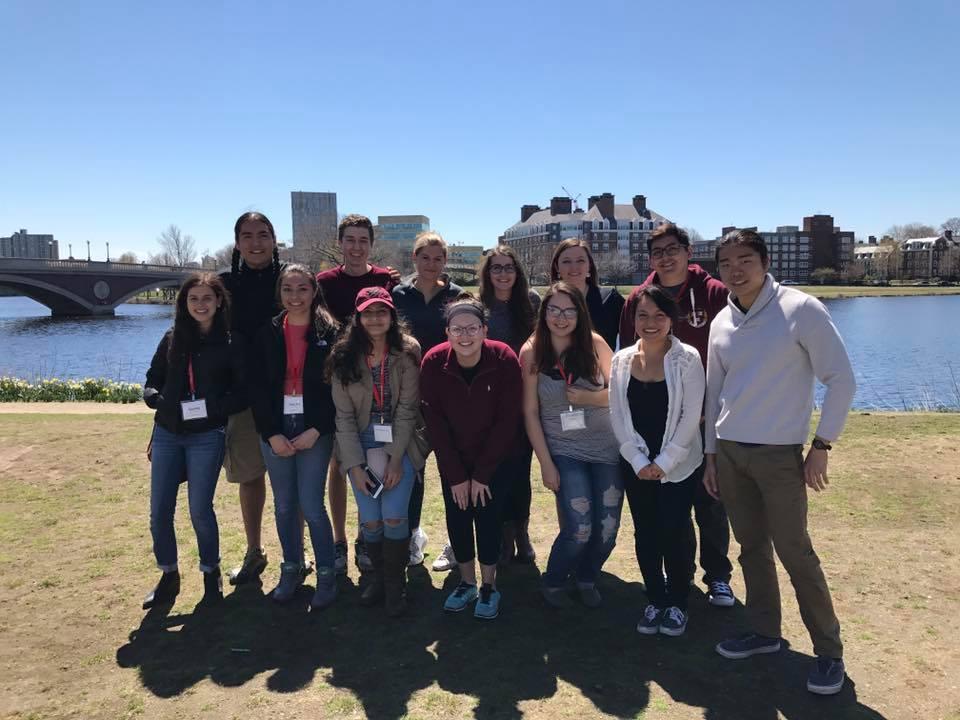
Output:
[150, 425, 226, 572]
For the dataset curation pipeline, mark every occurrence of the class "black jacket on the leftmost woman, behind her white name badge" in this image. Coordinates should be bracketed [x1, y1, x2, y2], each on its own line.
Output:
[143, 329, 247, 434]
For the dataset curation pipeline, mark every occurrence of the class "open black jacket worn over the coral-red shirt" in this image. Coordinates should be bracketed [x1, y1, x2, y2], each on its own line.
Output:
[249, 311, 337, 442]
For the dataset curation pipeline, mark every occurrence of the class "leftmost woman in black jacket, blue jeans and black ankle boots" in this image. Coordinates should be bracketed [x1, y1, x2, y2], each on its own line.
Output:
[143, 273, 247, 610]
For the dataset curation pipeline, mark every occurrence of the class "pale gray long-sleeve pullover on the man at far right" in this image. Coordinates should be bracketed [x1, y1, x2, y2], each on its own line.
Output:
[705, 275, 856, 453]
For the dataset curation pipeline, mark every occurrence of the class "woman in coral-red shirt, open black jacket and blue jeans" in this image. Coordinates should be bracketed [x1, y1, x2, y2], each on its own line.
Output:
[250, 265, 338, 610]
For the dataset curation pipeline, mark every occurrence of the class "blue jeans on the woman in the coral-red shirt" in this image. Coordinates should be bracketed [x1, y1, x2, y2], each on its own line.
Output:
[260, 415, 334, 568]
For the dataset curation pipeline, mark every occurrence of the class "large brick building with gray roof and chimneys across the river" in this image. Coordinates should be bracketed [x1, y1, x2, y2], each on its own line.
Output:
[499, 193, 668, 282]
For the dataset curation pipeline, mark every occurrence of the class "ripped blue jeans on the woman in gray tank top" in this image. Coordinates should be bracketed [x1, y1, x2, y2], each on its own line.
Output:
[543, 456, 623, 588]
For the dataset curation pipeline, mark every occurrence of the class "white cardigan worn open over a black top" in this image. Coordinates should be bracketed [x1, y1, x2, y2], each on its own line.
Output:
[610, 336, 706, 482]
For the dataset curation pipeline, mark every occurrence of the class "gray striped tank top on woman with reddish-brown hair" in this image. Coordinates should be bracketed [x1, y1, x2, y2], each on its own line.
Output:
[537, 370, 620, 464]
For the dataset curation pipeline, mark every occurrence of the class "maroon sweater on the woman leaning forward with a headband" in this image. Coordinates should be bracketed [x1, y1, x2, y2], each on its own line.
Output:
[420, 340, 523, 487]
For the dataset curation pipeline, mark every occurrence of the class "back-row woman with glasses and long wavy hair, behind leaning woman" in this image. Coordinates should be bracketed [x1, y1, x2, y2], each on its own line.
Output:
[480, 245, 540, 565]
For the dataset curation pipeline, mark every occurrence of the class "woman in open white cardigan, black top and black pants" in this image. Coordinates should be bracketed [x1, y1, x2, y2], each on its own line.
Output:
[610, 285, 705, 637]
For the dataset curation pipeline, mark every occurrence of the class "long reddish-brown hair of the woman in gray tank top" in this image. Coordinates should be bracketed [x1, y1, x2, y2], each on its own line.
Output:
[530, 282, 600, 382]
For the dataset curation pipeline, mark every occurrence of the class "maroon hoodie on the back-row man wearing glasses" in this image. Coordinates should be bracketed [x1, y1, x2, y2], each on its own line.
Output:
[620, 263, 727, 367]
